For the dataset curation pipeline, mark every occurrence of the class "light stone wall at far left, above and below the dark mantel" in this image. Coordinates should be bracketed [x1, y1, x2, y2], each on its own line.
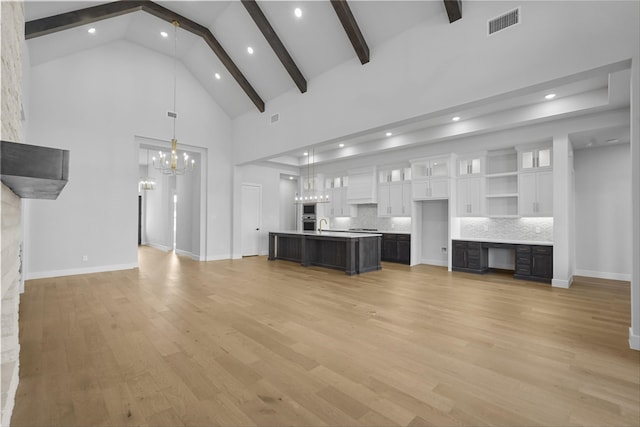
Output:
[0, 0, 24, 425]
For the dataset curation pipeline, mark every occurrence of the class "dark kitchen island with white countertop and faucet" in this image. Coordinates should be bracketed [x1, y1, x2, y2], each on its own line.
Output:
[268, 231, 382, 275]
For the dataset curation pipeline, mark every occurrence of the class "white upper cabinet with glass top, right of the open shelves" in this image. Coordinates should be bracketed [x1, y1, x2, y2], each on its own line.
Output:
[518, 147, 553, 217]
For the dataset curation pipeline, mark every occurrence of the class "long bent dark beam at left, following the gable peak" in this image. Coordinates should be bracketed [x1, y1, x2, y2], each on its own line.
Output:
[25, 0, 264, 112]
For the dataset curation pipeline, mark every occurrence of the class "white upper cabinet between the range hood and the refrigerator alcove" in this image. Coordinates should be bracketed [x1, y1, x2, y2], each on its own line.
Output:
[378, 167, 411, 217]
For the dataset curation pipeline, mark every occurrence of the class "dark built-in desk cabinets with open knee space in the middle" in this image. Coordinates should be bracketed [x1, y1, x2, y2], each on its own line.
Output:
[451, 240, 553, 283]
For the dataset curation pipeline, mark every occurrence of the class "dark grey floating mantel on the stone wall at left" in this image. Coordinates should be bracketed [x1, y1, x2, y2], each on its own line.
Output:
[0, 141, 69, 200]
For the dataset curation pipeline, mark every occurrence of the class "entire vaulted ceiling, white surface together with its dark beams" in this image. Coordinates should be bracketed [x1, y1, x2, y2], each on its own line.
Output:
[25, 0, 461, 118]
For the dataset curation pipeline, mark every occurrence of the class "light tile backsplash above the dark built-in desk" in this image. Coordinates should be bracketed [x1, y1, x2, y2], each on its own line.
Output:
[460, 218, 553, 242]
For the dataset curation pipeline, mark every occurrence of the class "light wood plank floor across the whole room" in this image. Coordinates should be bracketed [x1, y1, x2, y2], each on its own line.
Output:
[12, 248, 640, 426]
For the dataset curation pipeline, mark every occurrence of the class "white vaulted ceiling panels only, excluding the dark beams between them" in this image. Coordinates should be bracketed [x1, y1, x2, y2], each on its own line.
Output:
[25, 0, 448, 118]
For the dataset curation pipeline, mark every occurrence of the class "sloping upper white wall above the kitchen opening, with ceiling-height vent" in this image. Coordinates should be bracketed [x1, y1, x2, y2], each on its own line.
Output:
[233, 1, 640, 164]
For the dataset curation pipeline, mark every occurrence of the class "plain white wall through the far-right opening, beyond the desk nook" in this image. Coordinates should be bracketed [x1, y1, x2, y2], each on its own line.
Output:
[574, 144, 632, 280]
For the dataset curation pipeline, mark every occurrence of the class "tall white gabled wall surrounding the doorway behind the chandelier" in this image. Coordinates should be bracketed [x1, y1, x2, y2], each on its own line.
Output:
[25, 41, 231, 278]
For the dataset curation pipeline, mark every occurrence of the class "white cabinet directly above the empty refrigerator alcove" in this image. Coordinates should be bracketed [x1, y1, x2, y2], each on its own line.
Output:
[411, 157, 450, 200]
